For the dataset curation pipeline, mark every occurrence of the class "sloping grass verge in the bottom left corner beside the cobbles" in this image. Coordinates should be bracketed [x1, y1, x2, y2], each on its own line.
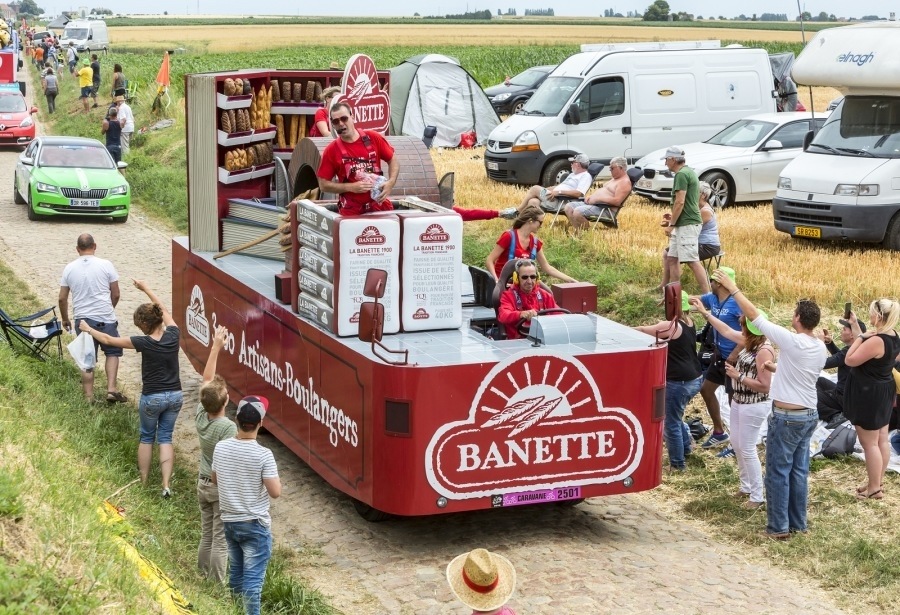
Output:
[0, 265, 333, 615]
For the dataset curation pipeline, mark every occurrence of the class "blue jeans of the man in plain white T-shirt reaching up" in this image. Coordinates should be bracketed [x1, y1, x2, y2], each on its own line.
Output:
[766, 406, 819, 534]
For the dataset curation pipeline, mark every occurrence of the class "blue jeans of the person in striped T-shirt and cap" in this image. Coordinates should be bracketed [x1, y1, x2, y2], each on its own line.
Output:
[225, 519, 272, 615]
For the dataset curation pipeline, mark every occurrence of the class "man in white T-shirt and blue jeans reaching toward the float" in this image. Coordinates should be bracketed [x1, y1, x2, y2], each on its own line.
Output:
[713, 269, 826, 540]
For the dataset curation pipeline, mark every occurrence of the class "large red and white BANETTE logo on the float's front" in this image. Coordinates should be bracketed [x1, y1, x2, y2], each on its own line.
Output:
[425, 350, 644, 506]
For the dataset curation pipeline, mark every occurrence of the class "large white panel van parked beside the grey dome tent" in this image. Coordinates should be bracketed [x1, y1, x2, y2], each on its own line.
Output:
[484, 41, 775, 186]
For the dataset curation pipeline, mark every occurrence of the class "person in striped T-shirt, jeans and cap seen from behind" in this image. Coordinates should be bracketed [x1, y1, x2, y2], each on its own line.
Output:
[212, 396, 281, 615]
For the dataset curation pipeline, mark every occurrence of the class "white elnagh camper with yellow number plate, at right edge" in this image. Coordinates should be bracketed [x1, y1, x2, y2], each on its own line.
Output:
[772, 21, 900, 250]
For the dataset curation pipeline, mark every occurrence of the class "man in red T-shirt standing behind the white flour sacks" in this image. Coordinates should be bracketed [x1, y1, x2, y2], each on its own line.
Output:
[316, 101, 400, 216]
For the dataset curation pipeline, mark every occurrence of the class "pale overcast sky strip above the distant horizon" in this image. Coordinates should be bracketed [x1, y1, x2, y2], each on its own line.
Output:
[36, 0, 884, 18]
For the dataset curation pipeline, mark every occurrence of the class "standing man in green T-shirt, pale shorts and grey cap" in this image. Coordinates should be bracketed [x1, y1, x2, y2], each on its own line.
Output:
[663, 146, 709, 293]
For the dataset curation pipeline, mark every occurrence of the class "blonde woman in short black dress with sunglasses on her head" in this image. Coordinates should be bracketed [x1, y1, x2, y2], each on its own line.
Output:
[844, 299, 900, 500]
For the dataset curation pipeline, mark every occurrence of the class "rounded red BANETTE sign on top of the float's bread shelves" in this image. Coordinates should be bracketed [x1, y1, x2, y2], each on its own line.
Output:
[332, 53, 391, 134]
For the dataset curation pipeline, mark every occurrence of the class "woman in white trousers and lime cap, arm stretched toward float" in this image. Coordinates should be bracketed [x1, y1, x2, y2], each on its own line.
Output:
[691, 298, 775, 510]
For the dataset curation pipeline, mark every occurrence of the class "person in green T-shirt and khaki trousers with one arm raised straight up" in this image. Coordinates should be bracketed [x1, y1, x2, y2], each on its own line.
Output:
[194, 327, 237, 583]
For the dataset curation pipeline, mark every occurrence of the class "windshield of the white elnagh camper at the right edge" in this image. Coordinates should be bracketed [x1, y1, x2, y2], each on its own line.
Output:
[809, 96, 900, 158]
